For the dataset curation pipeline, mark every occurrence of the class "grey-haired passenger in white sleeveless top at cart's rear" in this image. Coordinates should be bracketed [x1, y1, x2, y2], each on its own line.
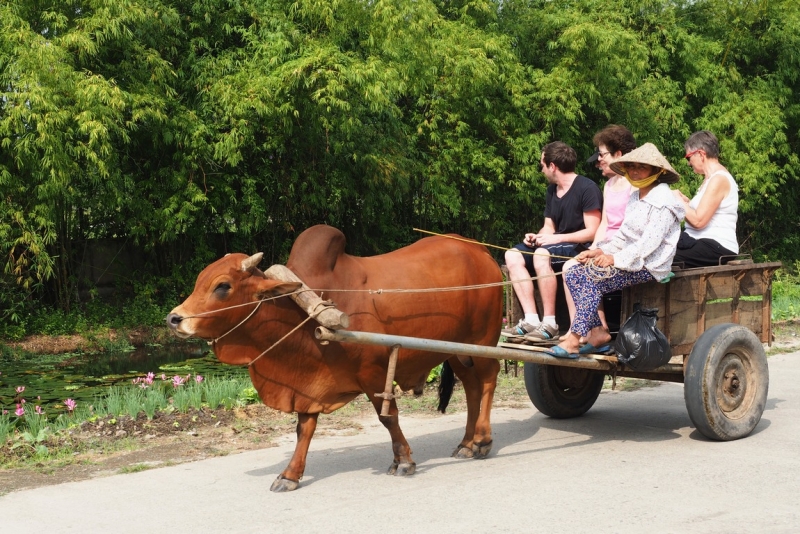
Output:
[673, 130, 739, 268]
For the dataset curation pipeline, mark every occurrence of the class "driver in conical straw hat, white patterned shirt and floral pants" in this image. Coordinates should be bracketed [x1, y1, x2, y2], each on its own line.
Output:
[551, 143, 684, 358]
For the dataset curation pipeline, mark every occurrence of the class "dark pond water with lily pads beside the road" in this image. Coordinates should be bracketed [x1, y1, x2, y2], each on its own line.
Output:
[0, 343, 247, 413]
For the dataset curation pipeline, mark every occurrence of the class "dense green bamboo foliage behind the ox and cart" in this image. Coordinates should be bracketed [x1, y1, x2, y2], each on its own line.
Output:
[0, 0, 800, 318]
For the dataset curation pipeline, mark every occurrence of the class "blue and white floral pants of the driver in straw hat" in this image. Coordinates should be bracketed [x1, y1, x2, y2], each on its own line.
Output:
[564, 265, 654, 337]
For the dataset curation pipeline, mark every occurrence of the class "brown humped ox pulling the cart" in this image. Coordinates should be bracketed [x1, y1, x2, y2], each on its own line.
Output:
[167, 226, 502, 491]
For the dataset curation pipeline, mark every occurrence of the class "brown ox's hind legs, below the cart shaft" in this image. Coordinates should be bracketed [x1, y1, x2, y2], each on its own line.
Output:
[448, 358, 500, 459]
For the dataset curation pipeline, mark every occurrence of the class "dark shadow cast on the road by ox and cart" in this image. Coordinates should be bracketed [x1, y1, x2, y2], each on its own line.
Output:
[239, 387, 744, 486]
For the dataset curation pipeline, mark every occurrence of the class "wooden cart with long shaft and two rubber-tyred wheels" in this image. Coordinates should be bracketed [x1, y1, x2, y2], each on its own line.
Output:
[316, 261, 781, 440]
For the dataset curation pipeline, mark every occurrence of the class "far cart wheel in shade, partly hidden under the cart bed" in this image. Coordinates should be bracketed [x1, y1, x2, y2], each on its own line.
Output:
[525, 362, 605, 419]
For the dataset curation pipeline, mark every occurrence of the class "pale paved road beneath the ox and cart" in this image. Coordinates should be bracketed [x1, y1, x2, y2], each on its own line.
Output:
[0, 352, 800, 534]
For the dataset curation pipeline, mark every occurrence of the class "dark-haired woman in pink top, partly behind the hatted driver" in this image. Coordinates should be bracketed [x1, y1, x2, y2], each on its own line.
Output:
[561, 124, 636, 339]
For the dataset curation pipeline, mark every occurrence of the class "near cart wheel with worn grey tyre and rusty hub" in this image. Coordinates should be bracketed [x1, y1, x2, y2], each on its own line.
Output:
[683, 323, 769, 441]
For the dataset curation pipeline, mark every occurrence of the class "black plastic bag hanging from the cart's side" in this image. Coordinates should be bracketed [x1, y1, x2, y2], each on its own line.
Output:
[614, 304, 672, 371]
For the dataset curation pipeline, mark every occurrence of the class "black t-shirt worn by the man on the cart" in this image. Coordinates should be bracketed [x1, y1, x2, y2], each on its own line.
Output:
[544, 175, 603, 234]
